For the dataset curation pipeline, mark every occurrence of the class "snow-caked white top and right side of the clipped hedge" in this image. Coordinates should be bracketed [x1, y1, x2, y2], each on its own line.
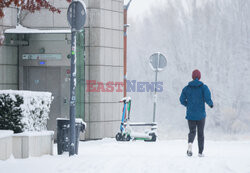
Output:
[0, 90, 53, 131]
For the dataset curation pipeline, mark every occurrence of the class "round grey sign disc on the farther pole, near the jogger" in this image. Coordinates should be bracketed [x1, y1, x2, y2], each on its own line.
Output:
[149, 52, 167, 72]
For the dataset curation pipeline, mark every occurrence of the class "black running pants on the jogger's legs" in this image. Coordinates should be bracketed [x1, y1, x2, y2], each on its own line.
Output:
[188, 118, 206, 153]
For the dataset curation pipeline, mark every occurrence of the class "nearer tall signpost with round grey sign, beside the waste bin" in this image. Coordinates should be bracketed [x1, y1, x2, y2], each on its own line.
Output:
[67, 0, 86, 156]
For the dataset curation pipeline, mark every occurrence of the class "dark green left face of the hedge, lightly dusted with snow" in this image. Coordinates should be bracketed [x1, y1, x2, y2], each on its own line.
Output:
[0, 94, 23, 133]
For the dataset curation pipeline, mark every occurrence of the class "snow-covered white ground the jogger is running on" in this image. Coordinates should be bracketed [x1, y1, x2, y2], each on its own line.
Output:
[0, 139, 250, 173]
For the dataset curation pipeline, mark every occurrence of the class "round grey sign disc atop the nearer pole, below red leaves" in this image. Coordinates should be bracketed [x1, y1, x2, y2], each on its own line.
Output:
[67, 0, 87, 31]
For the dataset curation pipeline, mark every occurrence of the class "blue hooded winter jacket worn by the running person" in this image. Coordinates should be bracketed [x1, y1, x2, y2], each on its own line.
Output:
[180, 79, 213, 120]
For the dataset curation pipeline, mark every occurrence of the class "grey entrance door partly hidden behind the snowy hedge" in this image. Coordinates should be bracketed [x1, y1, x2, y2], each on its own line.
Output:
[23, 66, 67, 131]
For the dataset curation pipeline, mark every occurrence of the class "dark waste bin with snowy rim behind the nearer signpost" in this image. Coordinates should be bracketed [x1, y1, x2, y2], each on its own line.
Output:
[57, 118, 86, 155]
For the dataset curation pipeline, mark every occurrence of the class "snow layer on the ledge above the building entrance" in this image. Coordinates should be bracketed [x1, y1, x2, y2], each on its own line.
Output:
[4, 25, 71, 34]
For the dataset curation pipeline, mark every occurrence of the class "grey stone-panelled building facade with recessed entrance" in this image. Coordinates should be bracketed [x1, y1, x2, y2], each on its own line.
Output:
[0, 0, 123, 139]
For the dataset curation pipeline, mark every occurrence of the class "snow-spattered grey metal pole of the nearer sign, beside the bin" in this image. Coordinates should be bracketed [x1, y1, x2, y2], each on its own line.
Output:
[69, 0, 76, 156]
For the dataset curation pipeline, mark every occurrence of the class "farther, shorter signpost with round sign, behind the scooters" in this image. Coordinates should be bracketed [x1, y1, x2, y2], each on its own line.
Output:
[149, 52, 167, 122]
